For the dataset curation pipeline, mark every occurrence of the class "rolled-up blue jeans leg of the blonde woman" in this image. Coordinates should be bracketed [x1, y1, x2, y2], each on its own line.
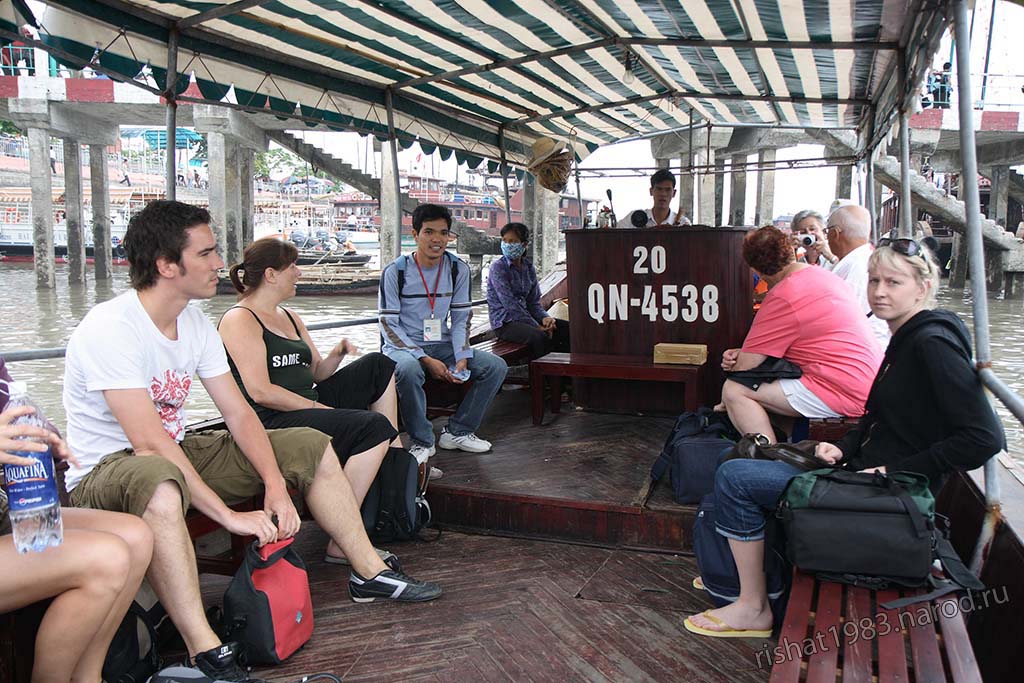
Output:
[715, 459, 803, 541]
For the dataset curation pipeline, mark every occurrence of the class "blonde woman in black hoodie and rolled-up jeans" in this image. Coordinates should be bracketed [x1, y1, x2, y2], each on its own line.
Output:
[685, 239, 1006, 637]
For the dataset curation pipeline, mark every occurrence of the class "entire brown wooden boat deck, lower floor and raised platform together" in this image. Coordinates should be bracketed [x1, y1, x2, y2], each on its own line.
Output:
[192, 390, 768, 682]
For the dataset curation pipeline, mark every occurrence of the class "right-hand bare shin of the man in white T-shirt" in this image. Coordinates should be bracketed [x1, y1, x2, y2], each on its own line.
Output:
[306, 445, 387, 578]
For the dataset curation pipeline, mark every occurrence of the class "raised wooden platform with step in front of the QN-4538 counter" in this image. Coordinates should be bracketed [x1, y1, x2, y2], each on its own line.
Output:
[428, 389, 695, 550]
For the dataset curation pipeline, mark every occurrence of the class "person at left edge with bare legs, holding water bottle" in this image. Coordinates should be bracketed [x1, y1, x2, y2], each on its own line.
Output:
[0, 358, 153, 681]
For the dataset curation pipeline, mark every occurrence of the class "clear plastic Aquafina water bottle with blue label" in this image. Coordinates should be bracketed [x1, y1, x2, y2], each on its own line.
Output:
[3, 382, 63, 553]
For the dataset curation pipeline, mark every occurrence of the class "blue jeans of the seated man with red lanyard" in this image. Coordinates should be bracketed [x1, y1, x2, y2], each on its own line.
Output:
[387, 342, 509, 446]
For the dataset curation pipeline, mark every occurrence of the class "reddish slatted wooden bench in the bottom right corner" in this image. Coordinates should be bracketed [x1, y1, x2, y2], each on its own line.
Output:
[770, 570, 981, 683]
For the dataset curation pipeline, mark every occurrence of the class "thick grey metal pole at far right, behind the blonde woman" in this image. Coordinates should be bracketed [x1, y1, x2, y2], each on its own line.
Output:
[953, 0, 1003, 573]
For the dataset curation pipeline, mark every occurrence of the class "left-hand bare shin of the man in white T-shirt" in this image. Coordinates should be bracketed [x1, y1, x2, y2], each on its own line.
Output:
[142, 481, 221, 656]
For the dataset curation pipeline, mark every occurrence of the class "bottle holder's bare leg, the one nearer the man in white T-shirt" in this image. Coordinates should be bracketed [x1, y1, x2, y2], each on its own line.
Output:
[63, 508, 153, 683]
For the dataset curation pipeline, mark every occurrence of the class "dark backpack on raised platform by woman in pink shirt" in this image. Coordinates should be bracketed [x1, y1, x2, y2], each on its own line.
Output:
[650, 408, 739, 505]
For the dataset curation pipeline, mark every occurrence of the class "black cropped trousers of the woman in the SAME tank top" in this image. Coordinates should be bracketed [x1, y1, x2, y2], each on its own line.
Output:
[256, 353, 398, 465]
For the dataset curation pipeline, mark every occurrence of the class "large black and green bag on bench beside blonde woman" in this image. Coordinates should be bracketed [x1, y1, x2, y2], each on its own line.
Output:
[777, 469, 984, 608]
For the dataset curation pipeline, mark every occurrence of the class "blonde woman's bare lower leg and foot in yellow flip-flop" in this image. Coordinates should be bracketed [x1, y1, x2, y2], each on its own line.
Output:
[690, 539, 772, 631]
